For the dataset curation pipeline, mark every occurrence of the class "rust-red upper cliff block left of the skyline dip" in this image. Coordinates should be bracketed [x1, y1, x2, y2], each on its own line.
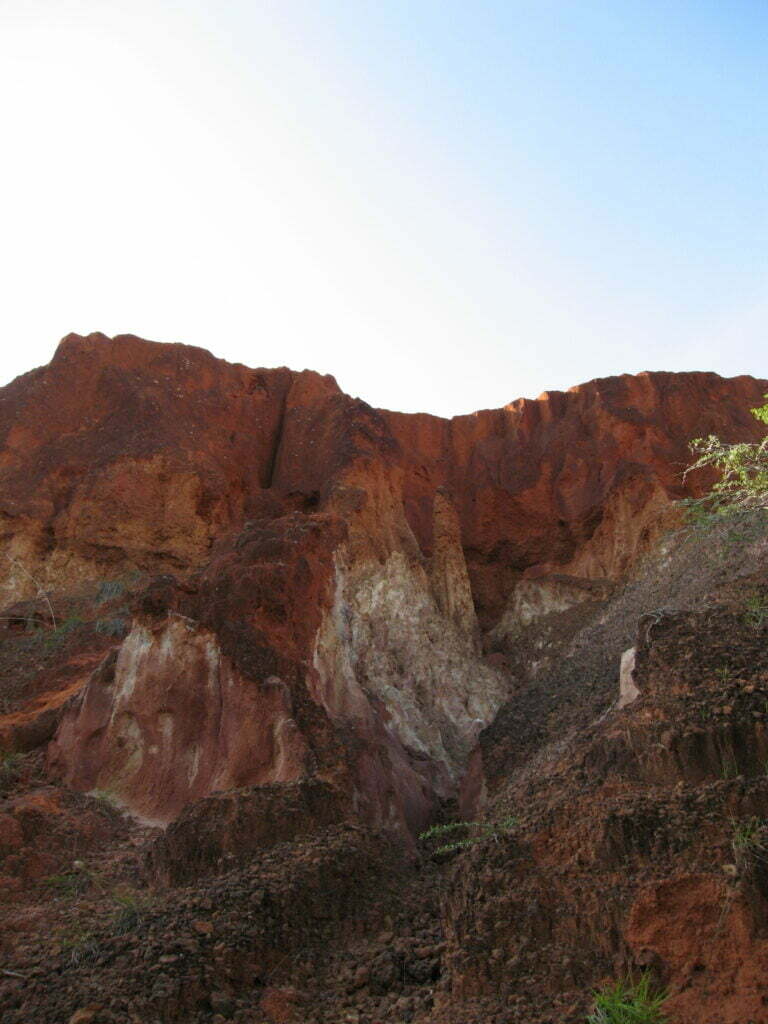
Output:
[0, 335, 340, 604]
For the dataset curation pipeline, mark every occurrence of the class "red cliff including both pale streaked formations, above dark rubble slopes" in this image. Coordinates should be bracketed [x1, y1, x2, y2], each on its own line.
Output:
[0, 335, 768, 830]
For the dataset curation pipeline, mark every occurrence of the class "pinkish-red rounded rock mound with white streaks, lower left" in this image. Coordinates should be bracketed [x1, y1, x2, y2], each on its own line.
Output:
[49, 615, 308, 821]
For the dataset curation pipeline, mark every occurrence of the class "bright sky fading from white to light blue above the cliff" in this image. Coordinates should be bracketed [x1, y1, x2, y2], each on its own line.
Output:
[0, 0, 768, 416]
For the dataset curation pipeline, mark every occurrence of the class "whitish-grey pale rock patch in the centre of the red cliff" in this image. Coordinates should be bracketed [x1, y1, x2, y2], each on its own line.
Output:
[314, 552, 505, 777]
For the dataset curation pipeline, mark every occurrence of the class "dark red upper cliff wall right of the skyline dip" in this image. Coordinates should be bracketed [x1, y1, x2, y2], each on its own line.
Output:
[384, 373, 768, 629]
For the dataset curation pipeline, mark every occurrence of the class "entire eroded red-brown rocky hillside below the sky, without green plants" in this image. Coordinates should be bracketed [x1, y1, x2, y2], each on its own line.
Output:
[0, 335, 768, 1024]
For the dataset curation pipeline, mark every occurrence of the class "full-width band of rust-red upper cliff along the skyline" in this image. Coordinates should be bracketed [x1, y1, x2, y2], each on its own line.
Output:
[0, 335, 768, 626]
